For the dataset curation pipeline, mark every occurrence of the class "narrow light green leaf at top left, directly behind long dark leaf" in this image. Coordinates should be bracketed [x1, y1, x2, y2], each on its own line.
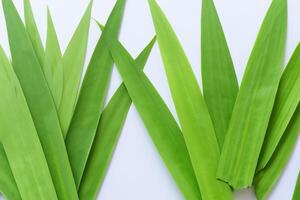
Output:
[24, 0, 46, 67]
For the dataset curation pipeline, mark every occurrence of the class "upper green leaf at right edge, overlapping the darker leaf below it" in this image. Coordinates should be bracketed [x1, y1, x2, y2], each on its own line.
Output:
[257, 44, 300, 170]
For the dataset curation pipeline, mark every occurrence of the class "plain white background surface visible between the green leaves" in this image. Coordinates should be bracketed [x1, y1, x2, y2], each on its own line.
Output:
[0, 0, 300, 200]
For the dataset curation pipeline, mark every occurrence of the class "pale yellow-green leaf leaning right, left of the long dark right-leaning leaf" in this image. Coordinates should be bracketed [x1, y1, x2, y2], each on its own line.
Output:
[58, 0, 93, 137]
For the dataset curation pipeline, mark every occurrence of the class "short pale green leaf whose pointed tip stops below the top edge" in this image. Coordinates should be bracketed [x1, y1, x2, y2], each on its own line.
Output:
[44, 9, 63, 109]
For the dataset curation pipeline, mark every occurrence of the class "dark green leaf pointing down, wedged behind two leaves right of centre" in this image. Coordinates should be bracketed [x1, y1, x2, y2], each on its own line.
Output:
[201, 0, 239, 149]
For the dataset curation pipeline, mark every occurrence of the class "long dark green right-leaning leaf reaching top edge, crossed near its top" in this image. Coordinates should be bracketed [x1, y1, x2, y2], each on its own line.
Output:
[66, 0, 126, 188]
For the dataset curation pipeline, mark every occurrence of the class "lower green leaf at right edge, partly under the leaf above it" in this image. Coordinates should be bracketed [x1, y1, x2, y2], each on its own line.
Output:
[254, 105, 300, 200]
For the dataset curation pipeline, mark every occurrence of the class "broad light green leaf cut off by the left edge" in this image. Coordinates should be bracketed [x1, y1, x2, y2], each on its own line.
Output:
[0, 45, 57, 200]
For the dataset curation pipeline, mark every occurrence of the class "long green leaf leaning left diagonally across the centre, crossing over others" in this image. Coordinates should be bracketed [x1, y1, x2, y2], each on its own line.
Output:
[107, 40, 201, 200]
